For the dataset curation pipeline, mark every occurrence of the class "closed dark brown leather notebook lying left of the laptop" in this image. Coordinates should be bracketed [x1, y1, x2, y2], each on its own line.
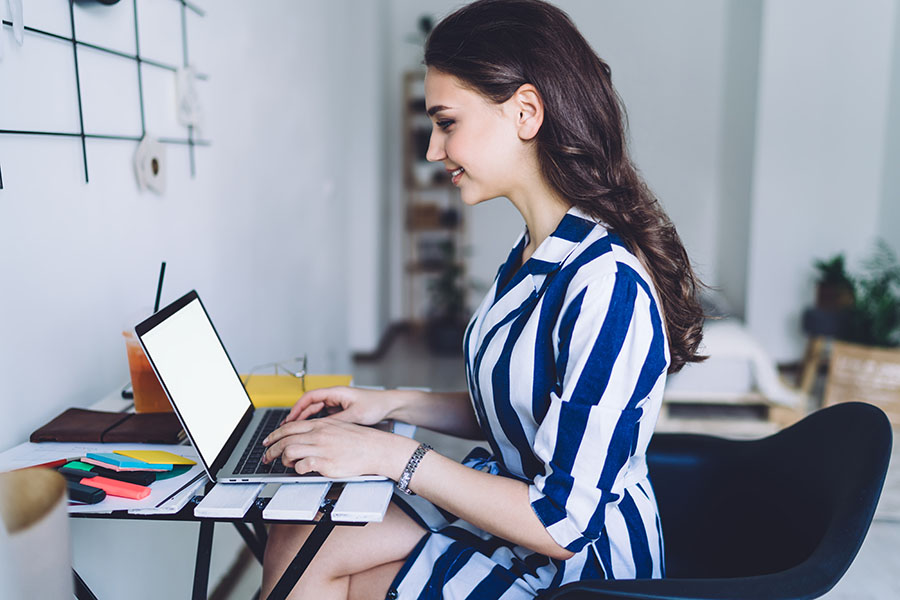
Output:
[30, 408, 184, 444]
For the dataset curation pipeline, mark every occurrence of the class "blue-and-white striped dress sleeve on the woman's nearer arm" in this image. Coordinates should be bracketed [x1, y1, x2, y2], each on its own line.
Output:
[529, 268, 668, 552]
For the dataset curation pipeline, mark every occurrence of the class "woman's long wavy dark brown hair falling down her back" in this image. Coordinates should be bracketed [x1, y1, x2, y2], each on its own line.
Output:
[425, 0, 705, 373]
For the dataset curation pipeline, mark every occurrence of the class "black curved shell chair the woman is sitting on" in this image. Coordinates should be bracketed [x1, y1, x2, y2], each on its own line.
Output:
[541, 402, 892, 600]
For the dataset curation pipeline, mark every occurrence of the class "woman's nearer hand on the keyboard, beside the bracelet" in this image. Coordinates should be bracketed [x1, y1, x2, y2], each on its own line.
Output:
[263, 417, 418, 479]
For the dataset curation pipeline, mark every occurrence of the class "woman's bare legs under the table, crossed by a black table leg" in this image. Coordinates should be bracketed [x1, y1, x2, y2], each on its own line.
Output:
[260, 504, 425, 600]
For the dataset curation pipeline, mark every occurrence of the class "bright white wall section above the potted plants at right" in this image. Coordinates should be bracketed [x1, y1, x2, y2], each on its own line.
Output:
[746, 0, 897, 360]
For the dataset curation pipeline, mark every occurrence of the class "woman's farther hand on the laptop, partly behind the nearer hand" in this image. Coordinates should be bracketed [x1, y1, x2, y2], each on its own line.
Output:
[284, 387, 394, 425]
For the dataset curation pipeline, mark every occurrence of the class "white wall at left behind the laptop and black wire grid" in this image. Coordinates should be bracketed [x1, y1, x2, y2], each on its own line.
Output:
[0, 0, 383, 598]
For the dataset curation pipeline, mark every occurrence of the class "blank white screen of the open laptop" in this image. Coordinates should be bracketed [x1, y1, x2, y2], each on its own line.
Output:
[141, 299, 250, 465]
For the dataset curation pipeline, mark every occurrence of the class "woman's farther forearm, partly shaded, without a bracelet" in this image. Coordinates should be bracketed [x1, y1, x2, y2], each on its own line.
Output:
[386, 390, 484, 440]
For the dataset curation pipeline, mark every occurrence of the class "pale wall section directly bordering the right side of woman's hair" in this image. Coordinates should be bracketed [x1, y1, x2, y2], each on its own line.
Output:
[559, 0, 727, 284]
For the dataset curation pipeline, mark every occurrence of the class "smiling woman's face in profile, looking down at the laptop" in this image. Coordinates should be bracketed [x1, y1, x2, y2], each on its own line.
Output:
[425, 68, 526, 205]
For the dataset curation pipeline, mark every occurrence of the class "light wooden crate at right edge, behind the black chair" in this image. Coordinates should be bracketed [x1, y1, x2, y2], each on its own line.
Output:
[825, 341, 900, 428]
